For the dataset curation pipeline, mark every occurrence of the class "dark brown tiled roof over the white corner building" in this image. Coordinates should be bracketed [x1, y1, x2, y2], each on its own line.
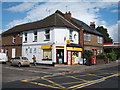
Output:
[3, 12, 79, 35]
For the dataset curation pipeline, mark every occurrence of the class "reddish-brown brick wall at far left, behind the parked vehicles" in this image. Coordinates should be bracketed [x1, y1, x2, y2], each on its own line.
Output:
[2, 34, 22, 60]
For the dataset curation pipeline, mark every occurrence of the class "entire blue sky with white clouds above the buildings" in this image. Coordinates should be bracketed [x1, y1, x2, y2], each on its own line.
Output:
[0, 0, 120, 42]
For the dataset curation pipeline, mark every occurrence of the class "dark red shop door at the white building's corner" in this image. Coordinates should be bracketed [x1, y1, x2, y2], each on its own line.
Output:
[56, 49, 64, 64]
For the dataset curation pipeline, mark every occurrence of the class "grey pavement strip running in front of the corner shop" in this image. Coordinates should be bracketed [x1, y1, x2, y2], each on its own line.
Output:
[31, 60, 120, 74]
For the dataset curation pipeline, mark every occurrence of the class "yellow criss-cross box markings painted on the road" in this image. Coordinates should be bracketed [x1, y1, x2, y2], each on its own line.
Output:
[21, 73, 120, 89]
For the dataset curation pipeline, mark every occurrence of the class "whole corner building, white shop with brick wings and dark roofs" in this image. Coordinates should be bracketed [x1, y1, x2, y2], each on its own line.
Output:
[1, 10, 103, 65]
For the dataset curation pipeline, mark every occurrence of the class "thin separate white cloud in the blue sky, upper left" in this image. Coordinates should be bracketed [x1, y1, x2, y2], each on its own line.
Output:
[6, 2, 37, 12]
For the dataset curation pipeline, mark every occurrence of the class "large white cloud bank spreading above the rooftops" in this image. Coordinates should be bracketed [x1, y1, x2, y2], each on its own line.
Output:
[4, 2, 118, 41]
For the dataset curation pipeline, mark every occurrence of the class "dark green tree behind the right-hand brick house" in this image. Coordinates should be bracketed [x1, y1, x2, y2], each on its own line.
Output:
[96, 26, 113, 43]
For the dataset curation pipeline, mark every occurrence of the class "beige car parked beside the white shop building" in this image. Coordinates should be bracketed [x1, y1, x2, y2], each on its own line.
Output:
[10, 57, 30, 67]
